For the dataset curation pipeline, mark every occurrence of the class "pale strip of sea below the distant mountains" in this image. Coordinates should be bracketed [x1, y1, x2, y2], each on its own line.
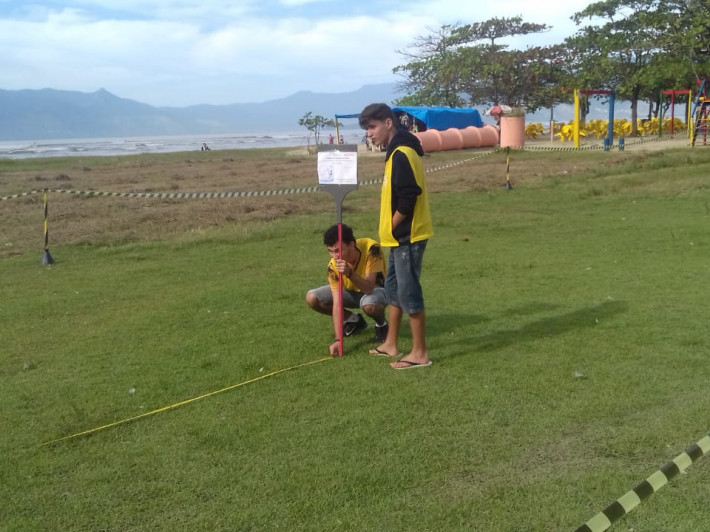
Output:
[0, 129, 363, 159]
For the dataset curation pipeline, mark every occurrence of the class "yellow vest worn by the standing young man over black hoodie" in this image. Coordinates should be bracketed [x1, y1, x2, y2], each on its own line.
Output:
[379, 146, 434, 247]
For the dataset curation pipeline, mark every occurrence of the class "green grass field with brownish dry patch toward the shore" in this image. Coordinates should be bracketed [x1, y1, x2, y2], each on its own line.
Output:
[0, 143, 710, 532]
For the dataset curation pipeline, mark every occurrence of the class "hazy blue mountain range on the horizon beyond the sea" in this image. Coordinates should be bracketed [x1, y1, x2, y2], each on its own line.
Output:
[0, 83, 402, 140]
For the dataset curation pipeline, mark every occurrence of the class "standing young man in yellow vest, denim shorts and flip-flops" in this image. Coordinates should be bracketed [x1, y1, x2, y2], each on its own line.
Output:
[360, 103, 434, 369]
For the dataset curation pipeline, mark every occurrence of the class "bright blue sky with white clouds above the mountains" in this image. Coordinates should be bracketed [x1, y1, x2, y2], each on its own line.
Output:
[0, 0, 592, 107]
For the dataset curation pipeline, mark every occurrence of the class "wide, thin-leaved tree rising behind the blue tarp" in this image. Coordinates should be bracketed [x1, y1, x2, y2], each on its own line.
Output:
[393, 17, 571, 112]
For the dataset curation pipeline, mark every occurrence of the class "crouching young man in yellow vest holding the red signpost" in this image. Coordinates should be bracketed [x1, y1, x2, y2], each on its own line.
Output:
[306, 224, 388, 355]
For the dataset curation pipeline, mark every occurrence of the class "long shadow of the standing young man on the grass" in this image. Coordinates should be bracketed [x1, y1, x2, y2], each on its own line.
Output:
[434, 301, 628, 358]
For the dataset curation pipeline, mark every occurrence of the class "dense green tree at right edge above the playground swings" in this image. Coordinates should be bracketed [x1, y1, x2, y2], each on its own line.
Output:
[566, 0, 710, 135]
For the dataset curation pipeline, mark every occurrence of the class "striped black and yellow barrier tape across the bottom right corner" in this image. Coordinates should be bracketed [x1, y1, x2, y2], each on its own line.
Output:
[576, 434, 710, 532]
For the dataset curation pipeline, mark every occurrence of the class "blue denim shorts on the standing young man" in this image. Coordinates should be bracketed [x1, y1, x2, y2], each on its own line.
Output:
[385, 240, 428, 314]
